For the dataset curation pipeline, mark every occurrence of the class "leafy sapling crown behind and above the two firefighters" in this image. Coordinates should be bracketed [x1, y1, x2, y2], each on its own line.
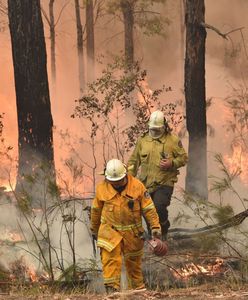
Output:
[72, 57, 183, 157]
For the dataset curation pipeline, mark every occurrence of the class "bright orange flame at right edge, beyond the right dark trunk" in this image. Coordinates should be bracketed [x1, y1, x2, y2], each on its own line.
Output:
[224, 143, 248, 185]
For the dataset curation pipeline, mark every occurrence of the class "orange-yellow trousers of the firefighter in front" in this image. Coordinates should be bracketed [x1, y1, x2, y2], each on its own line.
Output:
[101, 239, 144, 289]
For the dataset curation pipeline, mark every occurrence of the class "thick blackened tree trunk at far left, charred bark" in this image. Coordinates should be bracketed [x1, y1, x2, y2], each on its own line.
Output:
[8, 0, 54, 206]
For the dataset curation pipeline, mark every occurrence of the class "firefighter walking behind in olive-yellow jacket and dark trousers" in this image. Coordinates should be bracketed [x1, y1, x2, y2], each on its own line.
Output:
[128, 110, 188, 240]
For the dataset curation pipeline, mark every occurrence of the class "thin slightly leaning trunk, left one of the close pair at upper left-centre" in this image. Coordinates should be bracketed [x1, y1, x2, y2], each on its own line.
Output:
[75, 0, 85, 94]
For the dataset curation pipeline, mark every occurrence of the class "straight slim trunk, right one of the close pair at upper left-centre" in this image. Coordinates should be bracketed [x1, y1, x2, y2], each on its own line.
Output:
[86, 0, 95, 82]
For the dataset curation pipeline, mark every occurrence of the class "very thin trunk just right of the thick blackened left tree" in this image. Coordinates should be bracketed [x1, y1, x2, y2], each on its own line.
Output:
[49, 0, 56, 85]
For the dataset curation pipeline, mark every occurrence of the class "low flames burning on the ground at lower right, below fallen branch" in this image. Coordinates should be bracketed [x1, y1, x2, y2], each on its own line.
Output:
[170, 258, 226, 280]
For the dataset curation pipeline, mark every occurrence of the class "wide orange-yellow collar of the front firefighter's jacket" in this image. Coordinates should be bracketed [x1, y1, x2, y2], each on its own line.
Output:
[101, 174, 135, 200]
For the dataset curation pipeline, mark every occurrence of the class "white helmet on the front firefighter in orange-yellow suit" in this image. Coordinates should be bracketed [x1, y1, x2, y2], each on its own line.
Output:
[104, 159, 127, 181]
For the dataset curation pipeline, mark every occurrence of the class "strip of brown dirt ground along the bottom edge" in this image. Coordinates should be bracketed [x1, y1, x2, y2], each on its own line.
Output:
[0, 284, 248, 300]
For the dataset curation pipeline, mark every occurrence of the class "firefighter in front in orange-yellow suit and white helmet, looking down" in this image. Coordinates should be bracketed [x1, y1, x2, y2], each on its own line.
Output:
[91, 159, 161, 293]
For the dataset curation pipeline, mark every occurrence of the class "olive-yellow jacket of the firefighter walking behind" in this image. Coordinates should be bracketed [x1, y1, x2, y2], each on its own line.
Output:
[128, 133, 188, 193]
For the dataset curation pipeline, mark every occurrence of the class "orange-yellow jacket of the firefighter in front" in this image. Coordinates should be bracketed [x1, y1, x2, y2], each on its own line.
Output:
[91, 175, 160, 252]
